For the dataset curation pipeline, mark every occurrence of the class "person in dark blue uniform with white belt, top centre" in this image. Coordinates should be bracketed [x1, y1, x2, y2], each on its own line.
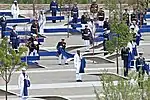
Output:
[71, 3, 79, 29]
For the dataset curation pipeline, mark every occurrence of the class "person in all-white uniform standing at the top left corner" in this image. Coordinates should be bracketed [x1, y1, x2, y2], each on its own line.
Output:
[11, 0, 19, 19]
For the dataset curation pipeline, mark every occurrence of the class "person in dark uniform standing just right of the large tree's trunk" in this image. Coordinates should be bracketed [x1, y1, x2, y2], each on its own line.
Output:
[121, 47, 130, 77]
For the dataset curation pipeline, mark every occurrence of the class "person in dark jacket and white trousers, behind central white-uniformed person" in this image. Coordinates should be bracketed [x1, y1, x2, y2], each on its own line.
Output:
[81, 25, 92, 52]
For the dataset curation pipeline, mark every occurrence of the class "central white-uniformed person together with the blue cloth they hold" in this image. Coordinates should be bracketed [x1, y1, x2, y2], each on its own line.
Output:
[74, 50, 86, 82]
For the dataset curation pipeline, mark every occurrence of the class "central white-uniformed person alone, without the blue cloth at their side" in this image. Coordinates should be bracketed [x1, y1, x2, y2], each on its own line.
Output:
[74, 50, 82, 82]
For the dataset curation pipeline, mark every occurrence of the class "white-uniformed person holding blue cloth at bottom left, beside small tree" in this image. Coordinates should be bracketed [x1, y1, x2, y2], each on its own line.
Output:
[18, 68, 31, 99]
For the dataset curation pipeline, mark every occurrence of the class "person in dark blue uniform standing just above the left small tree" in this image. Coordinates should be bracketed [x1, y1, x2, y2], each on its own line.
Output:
[10, 25, 20, 52]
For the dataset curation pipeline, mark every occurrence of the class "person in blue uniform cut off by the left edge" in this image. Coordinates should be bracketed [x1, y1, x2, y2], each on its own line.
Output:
[0, 15, 7, 38]
